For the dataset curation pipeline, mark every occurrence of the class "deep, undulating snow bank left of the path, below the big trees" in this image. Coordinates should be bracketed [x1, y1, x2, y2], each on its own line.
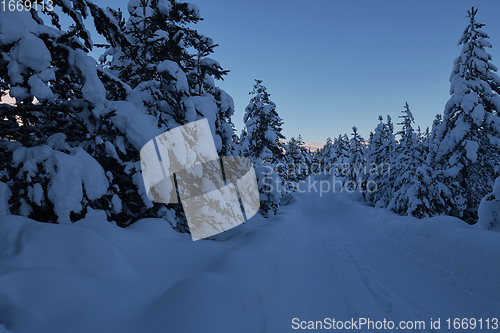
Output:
[0, 210, 270, 333]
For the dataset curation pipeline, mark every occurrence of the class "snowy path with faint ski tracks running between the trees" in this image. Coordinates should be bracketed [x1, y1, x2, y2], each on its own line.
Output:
[260, 180, 500, 332]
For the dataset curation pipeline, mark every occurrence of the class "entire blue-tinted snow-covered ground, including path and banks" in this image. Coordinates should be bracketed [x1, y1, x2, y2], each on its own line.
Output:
[0, 176, 500, 333]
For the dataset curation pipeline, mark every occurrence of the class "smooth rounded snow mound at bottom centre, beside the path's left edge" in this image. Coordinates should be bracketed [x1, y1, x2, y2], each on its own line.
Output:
[137, 272, 264, 333]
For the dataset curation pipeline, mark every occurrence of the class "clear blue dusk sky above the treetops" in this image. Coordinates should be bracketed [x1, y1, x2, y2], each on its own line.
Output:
[95, 0, 500, 142]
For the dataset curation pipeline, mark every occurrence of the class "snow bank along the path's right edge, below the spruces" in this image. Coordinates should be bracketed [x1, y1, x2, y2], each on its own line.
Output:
[364, 209, 500, 299]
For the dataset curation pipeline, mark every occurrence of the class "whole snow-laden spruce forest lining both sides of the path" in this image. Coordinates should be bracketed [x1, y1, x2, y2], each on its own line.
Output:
[0, 1, 500, 228]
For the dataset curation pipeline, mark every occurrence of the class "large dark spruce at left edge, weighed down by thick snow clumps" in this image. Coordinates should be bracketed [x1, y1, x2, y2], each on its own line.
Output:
[0, 0, 141, 223]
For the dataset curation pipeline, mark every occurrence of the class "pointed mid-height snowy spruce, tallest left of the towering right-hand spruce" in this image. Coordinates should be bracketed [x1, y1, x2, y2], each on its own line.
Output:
[388, 103, 433, 218]
